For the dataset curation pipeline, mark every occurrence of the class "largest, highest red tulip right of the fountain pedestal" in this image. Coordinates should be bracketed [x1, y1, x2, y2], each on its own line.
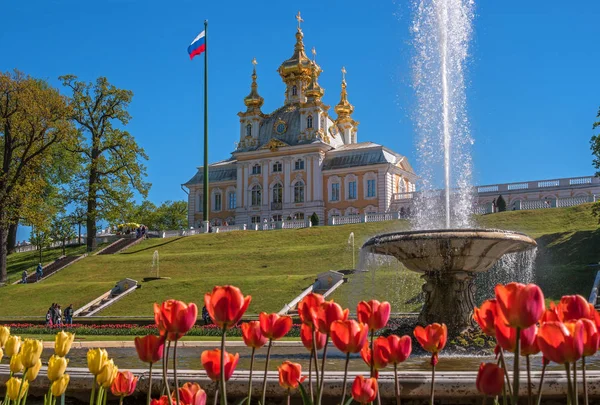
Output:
[496, 283, 546, 329]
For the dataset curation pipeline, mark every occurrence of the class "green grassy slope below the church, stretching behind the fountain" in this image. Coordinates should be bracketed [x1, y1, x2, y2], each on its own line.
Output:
[0, 205, 600, 316]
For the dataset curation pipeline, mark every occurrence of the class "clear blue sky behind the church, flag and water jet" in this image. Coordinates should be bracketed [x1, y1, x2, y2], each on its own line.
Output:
[0, 0, 600, 238]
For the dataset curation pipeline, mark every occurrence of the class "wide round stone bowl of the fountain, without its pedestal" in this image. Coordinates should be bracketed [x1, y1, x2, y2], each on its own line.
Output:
[363, 229, 537, 273]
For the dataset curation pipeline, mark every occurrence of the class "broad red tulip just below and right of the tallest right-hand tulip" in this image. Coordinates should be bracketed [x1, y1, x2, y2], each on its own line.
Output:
[537, 321, 584, 364]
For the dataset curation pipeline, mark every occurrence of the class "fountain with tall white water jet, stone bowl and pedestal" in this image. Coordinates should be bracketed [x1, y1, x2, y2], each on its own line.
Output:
[362, 0, 537, 333]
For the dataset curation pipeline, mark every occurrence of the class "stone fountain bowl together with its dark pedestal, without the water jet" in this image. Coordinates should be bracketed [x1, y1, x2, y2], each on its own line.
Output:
[363, 229, 537, 333]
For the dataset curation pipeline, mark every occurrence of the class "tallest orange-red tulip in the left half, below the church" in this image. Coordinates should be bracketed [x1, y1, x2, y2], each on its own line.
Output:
[204, 285, 252, 329]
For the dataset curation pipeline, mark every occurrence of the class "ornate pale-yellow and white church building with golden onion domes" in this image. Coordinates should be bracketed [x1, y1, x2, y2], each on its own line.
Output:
[183, 14, 417, 228]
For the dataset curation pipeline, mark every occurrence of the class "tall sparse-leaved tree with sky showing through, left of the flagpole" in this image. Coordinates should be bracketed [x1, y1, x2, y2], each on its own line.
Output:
[60, 75, 150, 251]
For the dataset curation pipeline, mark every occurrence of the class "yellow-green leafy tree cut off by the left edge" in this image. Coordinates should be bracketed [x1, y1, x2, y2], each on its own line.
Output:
[0, 70, 77, 284]
